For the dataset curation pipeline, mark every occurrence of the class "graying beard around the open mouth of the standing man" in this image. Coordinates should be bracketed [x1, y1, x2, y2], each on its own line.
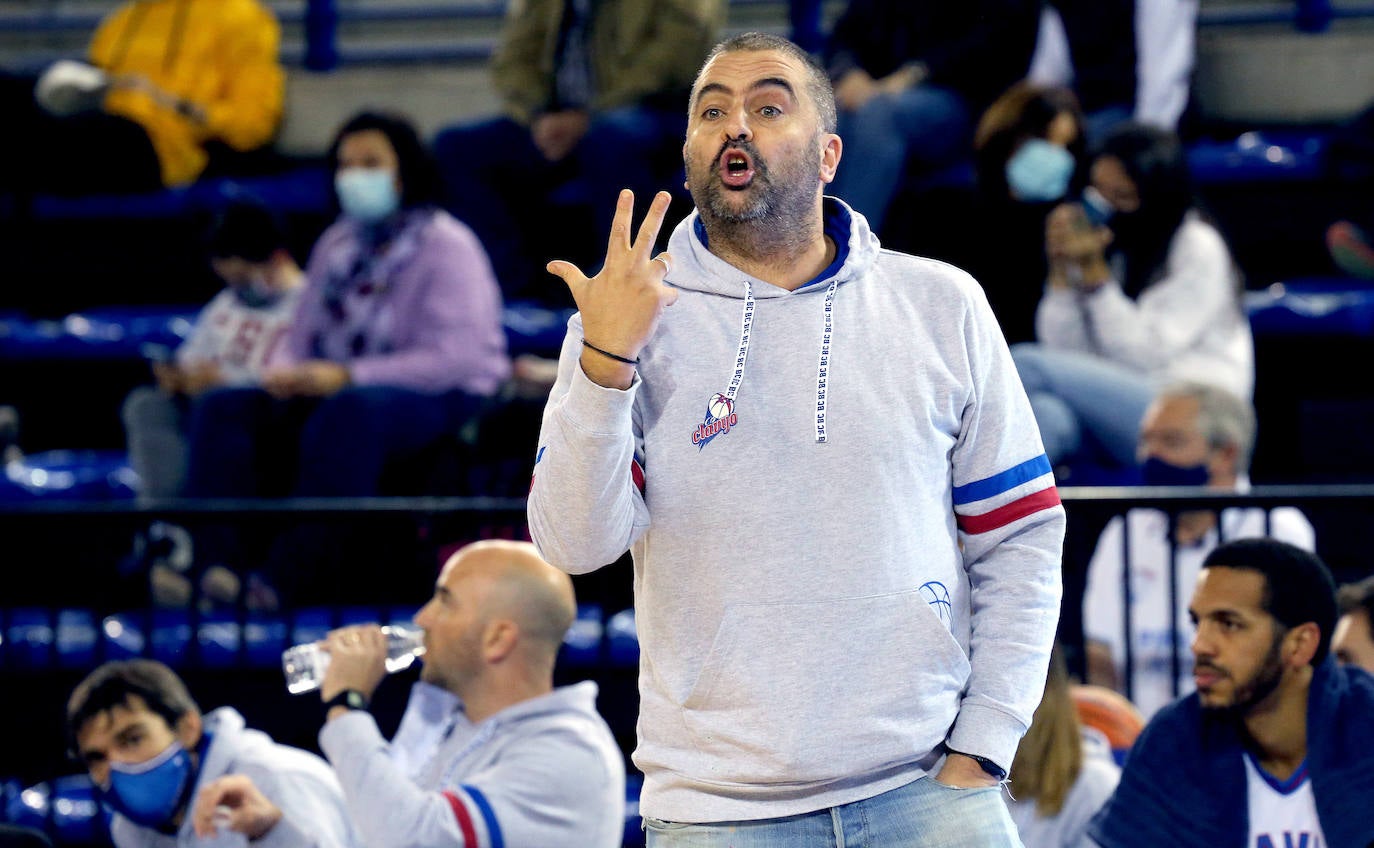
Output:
[687, 142, 820, 231]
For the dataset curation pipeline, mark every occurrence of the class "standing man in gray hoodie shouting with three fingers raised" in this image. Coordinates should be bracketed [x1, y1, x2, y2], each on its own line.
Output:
[529, 33, 1063, 847]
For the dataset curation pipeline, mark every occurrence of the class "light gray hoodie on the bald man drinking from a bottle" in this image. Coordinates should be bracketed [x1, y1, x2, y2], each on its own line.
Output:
[320, 680, 625, 848]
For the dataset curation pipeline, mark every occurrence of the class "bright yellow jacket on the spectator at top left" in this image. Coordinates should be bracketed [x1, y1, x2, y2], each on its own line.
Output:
[89, 0, 286, 186]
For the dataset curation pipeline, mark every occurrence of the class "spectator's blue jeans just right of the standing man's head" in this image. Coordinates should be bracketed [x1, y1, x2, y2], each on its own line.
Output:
[830, 85, 971, 235]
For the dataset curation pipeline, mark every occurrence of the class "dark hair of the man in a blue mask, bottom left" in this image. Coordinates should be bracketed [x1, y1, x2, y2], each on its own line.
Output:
[67, 660, 201, 755]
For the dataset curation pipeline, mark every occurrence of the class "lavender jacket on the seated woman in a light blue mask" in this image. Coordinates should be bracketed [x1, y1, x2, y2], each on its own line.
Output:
[272, 209, 511, 396]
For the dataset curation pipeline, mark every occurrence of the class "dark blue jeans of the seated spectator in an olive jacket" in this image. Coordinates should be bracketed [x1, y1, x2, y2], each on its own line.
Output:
[434, 106, 687, 301]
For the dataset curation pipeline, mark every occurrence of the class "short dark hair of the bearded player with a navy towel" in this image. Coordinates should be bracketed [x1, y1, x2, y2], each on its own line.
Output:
[1202, 537, 1337, 665]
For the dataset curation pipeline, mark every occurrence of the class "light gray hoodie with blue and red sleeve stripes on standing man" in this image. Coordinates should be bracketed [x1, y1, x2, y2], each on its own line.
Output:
[529, 198, 1063, 822]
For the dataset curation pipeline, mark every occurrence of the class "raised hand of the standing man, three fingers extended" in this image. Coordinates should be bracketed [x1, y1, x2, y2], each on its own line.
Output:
[547, 190, 677, 389]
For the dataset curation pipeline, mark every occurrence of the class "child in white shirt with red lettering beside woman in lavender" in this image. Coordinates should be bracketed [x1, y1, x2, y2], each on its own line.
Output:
[122, 201, 305, 498]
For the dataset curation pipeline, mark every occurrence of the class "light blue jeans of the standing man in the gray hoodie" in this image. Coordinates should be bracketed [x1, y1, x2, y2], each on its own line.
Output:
[644, 777, 1021, 848]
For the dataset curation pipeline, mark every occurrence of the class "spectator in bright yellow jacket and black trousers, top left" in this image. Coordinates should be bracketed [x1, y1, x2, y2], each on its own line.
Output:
[0, 0, 286, 194]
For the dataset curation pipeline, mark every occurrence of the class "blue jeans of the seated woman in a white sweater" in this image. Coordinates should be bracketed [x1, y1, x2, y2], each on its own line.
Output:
[1011, 344, 1157, 467]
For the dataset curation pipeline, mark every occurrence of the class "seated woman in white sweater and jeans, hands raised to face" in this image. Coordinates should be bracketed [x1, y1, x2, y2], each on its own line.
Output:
[1011, 124, 1254, 481]
